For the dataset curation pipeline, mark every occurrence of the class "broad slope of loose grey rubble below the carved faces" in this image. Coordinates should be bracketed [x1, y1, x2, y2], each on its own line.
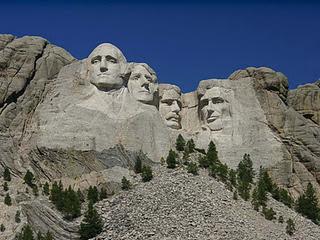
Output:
[95, 167, 320, 240]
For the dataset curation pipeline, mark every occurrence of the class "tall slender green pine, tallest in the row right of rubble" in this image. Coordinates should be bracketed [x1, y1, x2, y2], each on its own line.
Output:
[237, 154, 254, 201]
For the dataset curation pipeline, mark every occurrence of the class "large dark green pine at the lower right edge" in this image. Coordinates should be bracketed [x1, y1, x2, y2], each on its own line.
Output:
[297, 183, 320, 224]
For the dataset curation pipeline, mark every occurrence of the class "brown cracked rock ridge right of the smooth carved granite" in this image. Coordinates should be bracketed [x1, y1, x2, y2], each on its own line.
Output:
[229, 68, 320, 196]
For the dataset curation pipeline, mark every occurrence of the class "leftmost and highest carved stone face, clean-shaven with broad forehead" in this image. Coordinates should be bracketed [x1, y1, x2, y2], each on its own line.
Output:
[87, 43, 126, 91]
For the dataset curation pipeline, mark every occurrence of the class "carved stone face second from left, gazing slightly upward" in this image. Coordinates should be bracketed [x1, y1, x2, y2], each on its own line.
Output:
[128, 64, 158, 104]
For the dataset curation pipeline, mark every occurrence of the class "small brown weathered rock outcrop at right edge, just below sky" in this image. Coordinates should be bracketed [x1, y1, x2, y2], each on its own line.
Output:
[288, 82, 320, 125]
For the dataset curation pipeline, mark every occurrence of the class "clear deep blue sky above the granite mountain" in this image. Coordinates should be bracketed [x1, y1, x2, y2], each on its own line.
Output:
[0, 0, 320, 92]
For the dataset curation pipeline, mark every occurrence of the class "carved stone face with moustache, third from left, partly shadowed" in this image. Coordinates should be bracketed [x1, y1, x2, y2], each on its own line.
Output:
[159, 89, 181, 129]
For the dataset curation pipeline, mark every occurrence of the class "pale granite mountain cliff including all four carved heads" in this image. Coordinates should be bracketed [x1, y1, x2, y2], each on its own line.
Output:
[0, 35, 320, 239]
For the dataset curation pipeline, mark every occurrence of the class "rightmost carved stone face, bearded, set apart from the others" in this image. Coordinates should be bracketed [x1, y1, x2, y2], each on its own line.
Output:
[200, 87, 230, 131]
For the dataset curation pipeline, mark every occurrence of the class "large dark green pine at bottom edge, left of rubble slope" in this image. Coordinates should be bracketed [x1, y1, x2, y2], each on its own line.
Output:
[79, 201, 103, 240]
